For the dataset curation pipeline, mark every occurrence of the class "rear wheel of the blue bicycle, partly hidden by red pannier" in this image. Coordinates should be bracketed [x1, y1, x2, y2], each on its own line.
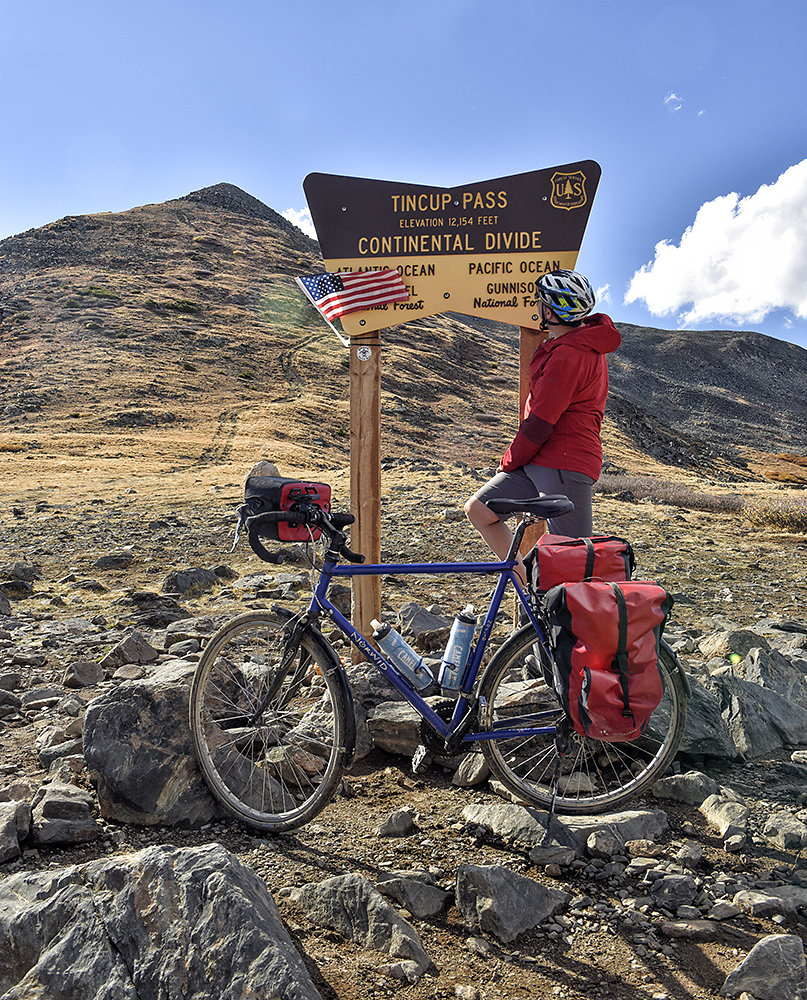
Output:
[480, 626, 687, 815]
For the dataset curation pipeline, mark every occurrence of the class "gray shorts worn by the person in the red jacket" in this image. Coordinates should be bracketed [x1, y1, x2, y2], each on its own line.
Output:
[474, 463, 595, 538]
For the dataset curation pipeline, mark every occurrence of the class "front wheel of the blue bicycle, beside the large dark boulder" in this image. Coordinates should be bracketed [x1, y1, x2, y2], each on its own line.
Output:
[189, 611, 352, 833]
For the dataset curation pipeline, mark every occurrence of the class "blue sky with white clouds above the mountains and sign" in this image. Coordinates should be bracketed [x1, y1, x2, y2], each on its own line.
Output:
[0, 0, 807, 347]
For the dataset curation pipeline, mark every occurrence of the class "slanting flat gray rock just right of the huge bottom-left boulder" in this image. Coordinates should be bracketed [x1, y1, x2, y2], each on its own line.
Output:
[290, 875, 432, 979]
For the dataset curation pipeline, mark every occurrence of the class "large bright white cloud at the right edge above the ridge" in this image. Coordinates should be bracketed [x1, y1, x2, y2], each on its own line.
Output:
[625, 160, 807, 324]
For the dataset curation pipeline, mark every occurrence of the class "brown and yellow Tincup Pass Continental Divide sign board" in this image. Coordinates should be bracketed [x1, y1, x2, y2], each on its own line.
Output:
[303, 160, 600, 336]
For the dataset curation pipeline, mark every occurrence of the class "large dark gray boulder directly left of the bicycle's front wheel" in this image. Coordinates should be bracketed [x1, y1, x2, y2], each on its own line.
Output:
[84, 660, 220, 826]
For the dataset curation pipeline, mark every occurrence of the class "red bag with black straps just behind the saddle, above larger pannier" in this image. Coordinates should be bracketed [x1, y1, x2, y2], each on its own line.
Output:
[524, 534, 636, 598]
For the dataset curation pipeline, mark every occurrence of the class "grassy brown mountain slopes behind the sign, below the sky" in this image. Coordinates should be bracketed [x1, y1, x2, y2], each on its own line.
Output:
[0, 184, 807, 492]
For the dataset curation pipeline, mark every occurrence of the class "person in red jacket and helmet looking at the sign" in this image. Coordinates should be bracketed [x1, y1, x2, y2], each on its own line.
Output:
[465, 269, 621, 572]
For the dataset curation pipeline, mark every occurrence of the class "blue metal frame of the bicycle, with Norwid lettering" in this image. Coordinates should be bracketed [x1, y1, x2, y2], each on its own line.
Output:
[308, 552, 556, 743]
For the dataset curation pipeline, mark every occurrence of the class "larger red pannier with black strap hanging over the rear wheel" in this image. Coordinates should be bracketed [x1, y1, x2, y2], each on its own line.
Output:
[545, 580, 672, 743]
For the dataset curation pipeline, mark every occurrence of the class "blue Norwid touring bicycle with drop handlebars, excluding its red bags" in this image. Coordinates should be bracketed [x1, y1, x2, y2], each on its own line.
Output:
[189, 496, 687, 832]
